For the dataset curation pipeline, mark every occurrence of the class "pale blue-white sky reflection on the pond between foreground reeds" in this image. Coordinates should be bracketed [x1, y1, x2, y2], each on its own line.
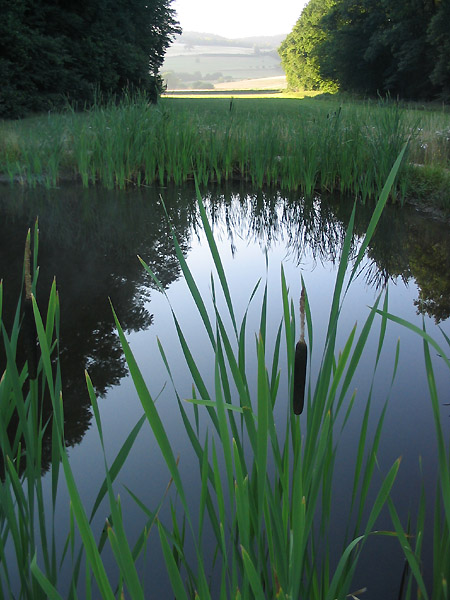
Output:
[2, 189, 450, 600]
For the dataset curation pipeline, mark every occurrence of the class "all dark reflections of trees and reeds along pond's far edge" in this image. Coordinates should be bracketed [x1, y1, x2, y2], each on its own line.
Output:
[0, 186, 450, 468]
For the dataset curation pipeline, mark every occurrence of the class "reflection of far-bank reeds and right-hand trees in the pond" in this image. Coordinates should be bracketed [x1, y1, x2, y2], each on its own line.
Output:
[200, 186, 450, 321]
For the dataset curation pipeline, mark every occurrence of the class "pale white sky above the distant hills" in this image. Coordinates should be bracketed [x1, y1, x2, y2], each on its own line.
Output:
[171, 0, 307, 38]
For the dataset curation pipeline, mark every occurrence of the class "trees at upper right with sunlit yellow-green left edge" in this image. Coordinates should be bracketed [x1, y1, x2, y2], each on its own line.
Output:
[279, 0, 450, 100]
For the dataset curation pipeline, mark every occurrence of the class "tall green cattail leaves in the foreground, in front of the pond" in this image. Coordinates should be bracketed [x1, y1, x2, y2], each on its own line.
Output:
[0, 156, 450, 600]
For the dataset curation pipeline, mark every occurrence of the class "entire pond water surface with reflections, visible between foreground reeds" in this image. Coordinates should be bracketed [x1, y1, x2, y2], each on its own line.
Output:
[0, 186, 450, 600]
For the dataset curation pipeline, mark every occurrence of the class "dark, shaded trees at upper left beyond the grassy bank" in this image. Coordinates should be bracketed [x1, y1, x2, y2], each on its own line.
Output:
[0, 0, 180, 117]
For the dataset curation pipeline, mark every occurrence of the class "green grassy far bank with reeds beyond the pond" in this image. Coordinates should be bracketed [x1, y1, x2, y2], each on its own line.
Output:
[0, 92, 450, 208]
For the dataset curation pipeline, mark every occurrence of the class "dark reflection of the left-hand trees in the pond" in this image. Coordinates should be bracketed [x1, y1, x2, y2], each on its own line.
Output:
[0, 187, 191, 462]
